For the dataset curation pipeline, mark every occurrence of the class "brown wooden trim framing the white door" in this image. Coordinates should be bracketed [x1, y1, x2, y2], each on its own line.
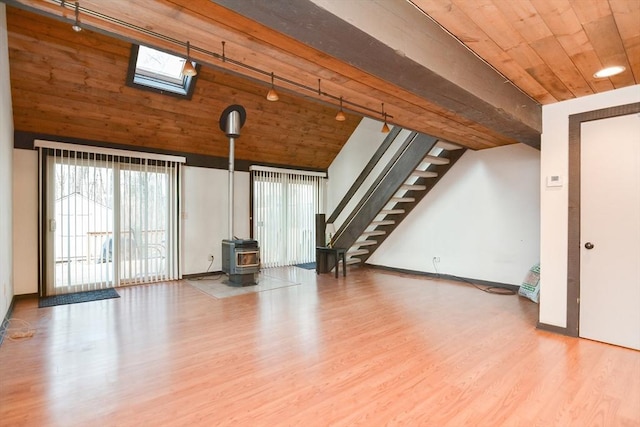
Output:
[566, 102, 640, 337]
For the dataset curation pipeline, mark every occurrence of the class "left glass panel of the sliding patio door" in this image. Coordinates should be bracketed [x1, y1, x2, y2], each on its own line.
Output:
[47, 156, 114, 295]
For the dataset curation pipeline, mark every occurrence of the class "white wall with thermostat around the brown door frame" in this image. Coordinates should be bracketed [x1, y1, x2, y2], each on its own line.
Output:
[540, 85, 640, 327]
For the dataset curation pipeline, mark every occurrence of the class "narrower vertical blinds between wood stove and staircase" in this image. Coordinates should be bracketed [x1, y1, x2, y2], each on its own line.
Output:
[251, 166, 326, 267]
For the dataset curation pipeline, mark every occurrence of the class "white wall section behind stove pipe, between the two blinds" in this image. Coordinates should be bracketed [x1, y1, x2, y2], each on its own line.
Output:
[182, 166, 250, 274]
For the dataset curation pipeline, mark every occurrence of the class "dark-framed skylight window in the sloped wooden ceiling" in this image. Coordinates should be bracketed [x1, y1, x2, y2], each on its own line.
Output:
[127, 45, 199, 99]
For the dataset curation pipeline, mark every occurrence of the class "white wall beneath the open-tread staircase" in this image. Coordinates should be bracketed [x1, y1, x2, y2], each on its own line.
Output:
[368, 144, 540, 285]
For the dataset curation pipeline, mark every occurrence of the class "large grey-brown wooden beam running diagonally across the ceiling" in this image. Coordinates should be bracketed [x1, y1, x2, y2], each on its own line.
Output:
[214, 0, 541, 147]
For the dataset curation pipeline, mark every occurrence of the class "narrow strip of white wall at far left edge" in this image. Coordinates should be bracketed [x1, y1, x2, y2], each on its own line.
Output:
[0, 4, 14, 321]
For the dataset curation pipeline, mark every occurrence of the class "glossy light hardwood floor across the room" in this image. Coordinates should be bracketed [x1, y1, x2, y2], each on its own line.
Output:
[0, 268, 640, 427]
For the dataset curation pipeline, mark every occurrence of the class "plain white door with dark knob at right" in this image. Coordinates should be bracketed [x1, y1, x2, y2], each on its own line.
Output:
[580, 114, 640, 349]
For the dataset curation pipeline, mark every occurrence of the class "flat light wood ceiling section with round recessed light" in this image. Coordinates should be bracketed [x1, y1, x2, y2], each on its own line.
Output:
[411, 0, 640, 104]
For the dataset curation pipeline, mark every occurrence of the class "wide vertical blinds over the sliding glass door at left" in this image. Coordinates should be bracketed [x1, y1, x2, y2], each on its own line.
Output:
[35, 141, 184, 295]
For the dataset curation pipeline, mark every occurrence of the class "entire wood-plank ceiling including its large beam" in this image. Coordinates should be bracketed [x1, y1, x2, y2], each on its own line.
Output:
[2, 0, 640, 169]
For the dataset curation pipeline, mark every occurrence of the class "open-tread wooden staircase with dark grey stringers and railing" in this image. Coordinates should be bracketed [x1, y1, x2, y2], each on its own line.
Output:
[329, 129, 465, 265]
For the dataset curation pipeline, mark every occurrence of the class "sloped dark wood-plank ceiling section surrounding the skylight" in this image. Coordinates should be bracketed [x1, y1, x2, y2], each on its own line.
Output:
[7, 8, 360, 169]
